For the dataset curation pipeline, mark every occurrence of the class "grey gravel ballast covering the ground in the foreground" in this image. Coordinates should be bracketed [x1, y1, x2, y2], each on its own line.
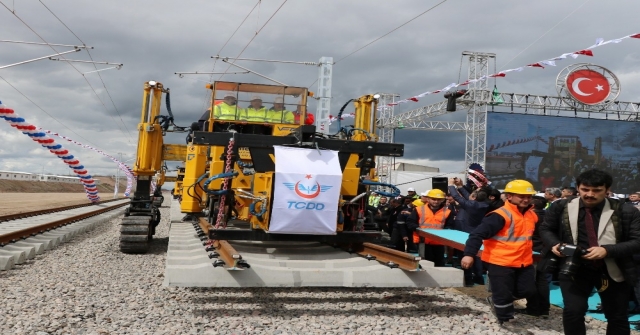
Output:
[0, 199, 606, 335]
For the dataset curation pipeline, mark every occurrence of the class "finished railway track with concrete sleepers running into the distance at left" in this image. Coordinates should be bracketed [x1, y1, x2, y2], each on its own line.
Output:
[0, 199, 129, 270]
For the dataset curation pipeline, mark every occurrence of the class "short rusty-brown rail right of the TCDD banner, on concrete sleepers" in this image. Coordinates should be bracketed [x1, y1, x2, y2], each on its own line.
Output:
[352, 242, 422, 271]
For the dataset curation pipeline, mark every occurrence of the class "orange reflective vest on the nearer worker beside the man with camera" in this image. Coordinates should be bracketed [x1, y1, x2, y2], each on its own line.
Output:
[481, 202, 538, 267]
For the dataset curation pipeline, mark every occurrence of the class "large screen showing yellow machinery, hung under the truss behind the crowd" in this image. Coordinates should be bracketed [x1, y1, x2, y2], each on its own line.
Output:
[486, 112, 640, 194]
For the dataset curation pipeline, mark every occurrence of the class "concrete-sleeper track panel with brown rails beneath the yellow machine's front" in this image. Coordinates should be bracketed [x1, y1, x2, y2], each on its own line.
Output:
[164, 201, 462, 287]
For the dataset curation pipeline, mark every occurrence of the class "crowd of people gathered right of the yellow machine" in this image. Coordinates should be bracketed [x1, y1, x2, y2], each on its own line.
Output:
[369, 169, 640, 335]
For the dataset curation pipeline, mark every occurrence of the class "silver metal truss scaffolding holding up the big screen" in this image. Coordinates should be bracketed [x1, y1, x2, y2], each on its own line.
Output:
[377, 51, 640, 180]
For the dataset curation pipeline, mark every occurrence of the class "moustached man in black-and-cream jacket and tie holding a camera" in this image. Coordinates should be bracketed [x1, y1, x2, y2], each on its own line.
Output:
[540, 169, 640, 335]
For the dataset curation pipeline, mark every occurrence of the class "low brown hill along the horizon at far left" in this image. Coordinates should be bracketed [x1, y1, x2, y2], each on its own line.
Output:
[0, 176, 127, 194]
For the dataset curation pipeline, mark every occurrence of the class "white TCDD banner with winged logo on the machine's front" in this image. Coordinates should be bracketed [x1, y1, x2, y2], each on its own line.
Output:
[269, 146, 342, 235]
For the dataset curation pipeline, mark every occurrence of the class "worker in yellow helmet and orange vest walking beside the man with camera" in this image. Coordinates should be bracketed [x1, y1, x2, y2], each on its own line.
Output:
[460, 179, 538, 324]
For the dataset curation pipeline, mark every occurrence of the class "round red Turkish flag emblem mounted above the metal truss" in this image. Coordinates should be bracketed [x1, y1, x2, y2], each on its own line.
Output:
[566, 70, 611, 105]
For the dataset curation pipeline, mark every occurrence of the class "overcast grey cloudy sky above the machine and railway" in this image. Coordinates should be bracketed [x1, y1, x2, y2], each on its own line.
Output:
[0, 0, 640, 184]
